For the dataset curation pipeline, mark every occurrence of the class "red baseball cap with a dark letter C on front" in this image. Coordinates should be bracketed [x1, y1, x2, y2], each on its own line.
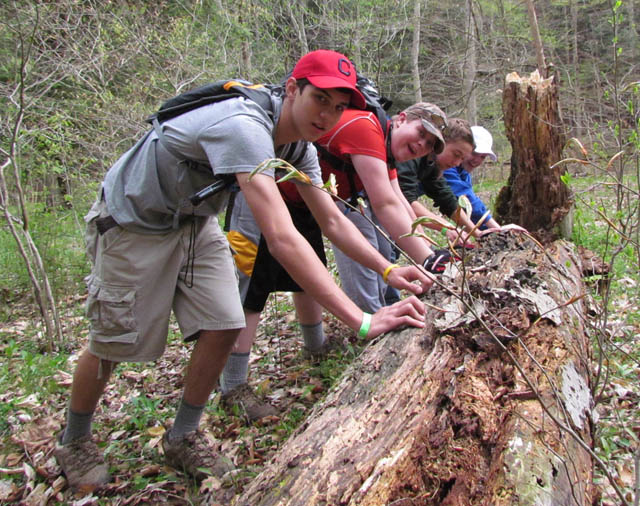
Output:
[291, 49, 366, 109]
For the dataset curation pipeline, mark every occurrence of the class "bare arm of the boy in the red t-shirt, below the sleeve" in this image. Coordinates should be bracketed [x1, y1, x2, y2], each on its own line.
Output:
[351, 155, 433, 264]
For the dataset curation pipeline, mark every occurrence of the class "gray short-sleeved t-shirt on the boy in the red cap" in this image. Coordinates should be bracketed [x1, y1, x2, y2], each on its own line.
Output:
[103, 96, 322, 234]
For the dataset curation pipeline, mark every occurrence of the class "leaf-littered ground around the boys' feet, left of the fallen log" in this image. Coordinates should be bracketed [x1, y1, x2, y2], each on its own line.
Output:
[0, 294, 370, 505]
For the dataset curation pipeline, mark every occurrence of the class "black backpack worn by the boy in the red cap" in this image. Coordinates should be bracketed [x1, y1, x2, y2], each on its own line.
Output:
[146, 79, 308, 206]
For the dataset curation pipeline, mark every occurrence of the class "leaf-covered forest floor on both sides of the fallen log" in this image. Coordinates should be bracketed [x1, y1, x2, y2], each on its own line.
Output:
[0, 175, 640, 506]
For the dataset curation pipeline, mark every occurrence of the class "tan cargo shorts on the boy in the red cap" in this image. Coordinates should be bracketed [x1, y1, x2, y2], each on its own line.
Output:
[85, 201, 245, 362]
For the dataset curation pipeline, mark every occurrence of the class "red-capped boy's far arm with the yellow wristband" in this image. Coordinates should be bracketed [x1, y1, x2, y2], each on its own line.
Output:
[298, 184, 433, 294]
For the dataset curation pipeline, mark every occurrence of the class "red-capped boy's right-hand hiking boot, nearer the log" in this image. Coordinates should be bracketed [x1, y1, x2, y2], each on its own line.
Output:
[162, 430, 234, 481]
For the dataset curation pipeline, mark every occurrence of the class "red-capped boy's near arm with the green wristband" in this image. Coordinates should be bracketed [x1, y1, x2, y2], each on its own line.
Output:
[236, 173, 424, 337]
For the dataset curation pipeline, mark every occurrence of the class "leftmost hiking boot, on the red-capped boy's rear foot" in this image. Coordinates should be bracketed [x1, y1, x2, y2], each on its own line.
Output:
[53, 436, 111, 492]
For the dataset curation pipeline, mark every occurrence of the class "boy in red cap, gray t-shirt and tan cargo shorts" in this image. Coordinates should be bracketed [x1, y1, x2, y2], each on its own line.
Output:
[55, 51, 424, 491]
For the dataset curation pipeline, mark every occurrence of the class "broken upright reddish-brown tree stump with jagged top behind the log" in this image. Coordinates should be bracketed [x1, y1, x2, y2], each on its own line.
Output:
[496, 71, 572, 242]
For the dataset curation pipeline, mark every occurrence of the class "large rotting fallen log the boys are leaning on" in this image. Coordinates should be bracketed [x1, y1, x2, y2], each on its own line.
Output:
[235, 234, 592, 506]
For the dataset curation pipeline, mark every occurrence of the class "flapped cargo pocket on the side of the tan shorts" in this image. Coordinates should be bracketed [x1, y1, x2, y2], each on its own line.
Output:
[87, 278, 138, 344]
